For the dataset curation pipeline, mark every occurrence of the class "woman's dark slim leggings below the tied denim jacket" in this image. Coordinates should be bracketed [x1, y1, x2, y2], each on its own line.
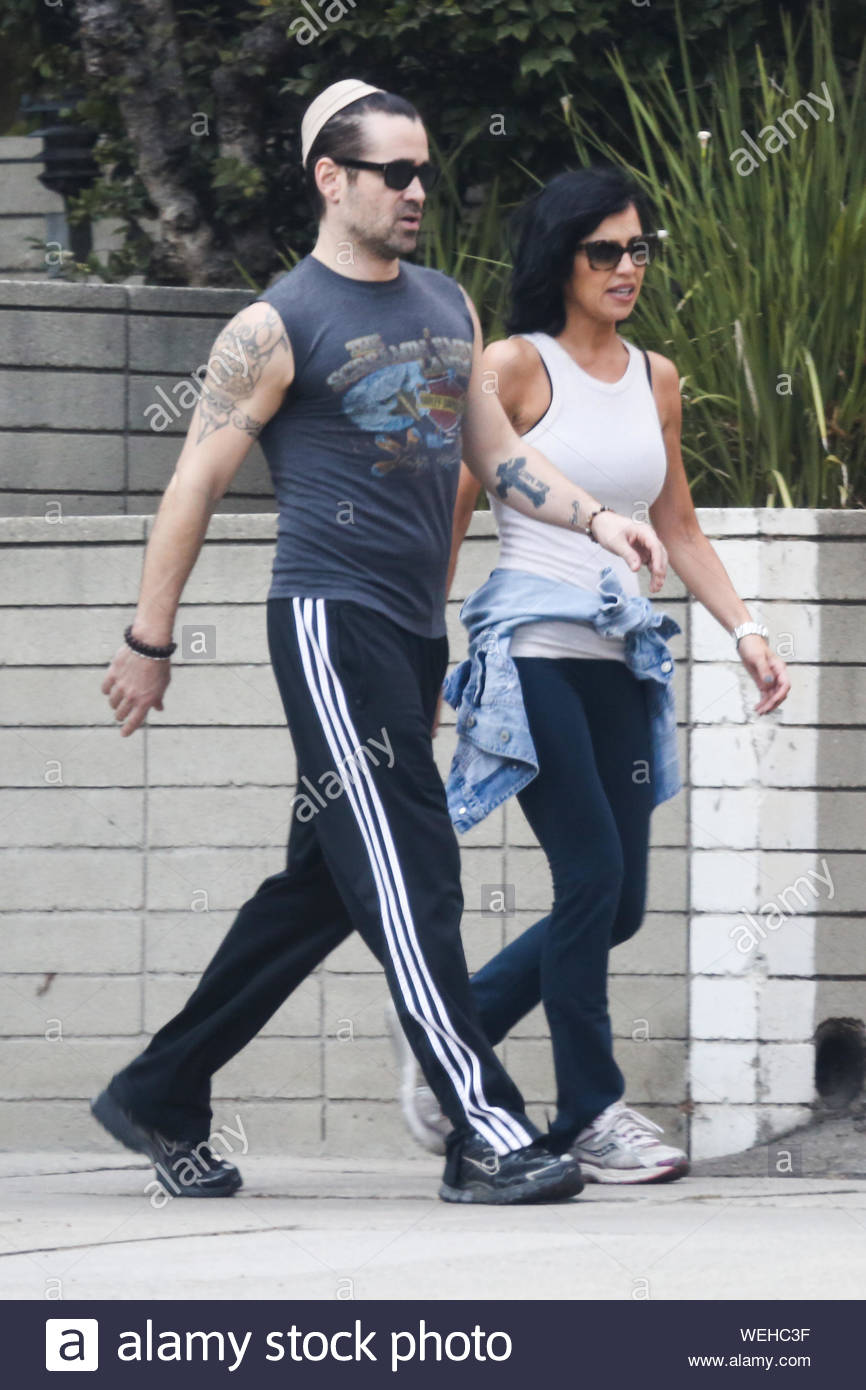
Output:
[473, 656, 653, 1151]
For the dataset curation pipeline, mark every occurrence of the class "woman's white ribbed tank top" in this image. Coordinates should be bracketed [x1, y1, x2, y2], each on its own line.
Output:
[488, 332, 667, 660]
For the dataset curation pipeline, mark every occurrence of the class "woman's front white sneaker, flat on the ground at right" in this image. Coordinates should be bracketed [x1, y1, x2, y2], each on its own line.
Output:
[571, 1101, 688, 1183]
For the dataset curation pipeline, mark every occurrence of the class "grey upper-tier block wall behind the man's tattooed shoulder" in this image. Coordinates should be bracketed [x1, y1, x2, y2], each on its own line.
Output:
[0, 279, 274, 518]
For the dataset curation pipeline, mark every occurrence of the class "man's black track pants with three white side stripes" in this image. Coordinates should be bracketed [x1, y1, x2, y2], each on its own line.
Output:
[111, 598, 538, 1154]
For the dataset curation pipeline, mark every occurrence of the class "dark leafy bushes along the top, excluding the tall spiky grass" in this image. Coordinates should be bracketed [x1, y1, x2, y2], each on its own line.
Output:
[0, 0, 839, 277]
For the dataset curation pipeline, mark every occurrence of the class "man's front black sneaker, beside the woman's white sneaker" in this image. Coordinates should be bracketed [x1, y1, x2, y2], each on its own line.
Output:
[439, 1134, 584, 1205]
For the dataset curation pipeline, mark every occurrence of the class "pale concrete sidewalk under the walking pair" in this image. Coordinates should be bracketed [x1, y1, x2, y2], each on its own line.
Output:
[0, 1151, 866, 1301]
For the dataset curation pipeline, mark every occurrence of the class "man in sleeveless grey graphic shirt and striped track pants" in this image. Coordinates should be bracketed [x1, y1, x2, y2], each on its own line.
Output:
[92, 79, 664, 1202]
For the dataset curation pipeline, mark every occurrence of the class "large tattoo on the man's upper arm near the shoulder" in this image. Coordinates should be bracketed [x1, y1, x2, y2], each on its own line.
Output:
[196, 304, 289, 443]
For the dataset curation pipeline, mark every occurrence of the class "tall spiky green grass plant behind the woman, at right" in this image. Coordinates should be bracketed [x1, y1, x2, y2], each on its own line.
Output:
[566, 7, 866, 507]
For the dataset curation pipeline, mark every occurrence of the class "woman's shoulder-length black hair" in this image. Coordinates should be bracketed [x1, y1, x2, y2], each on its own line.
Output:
[506, 164, 651, 338]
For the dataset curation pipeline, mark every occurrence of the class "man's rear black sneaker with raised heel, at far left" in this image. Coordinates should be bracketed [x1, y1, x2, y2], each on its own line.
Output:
[90, 1090, 243, 1197]
